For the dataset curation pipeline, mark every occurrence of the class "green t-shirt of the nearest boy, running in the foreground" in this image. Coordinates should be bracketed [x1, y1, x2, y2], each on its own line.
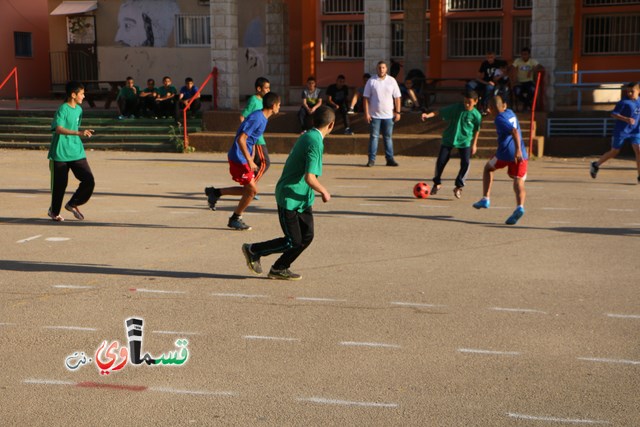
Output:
[276, 128, 324, 212]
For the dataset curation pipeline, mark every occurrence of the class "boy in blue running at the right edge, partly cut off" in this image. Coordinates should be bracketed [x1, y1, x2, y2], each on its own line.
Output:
[590, 82, 640, 184]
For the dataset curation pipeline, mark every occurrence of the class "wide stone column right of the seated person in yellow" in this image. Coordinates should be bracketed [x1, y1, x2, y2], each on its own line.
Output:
[531, 0, 581, 111]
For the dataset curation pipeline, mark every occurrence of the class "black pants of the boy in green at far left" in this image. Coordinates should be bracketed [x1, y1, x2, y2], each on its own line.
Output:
[49, 159, 95, 215]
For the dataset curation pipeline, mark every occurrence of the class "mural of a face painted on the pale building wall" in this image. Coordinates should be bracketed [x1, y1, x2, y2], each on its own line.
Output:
[115, 0, 180, 47]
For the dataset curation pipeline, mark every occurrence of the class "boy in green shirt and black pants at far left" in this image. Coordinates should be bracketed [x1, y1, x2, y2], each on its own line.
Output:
[48, 82, 95, 221]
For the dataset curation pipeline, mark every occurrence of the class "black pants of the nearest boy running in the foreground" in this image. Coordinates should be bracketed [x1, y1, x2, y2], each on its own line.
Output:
[251, 206, 313, 270]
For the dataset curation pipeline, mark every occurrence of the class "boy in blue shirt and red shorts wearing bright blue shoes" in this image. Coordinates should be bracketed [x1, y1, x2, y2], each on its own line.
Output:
[473, 95, 527, 225]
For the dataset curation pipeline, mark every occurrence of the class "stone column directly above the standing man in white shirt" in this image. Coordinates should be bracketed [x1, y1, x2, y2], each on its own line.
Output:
[364, 0, 391, 75]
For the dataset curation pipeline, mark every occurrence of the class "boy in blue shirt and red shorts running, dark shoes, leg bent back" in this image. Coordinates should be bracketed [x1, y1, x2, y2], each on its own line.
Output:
[204, 92, 280, 230]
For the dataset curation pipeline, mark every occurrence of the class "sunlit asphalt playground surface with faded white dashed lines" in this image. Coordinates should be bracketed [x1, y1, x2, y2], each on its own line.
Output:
[0, 150, 640, 426]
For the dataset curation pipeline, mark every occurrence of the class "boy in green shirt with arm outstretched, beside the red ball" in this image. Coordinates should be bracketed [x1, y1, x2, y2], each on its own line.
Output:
[422, 91, 482, 199]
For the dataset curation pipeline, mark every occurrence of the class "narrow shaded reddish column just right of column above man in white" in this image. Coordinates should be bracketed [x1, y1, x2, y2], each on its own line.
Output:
[404, 0, 427, 76]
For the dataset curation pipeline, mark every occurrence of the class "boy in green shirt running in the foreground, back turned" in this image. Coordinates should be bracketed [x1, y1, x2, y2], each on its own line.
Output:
[242, 106, 336, 280]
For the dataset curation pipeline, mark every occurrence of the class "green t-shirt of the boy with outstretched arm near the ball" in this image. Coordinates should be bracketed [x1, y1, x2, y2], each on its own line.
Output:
[439, 102, 482, 148]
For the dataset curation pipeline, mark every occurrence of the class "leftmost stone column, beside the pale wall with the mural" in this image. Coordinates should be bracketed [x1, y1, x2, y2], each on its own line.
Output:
[209, 0, 240, 110]
